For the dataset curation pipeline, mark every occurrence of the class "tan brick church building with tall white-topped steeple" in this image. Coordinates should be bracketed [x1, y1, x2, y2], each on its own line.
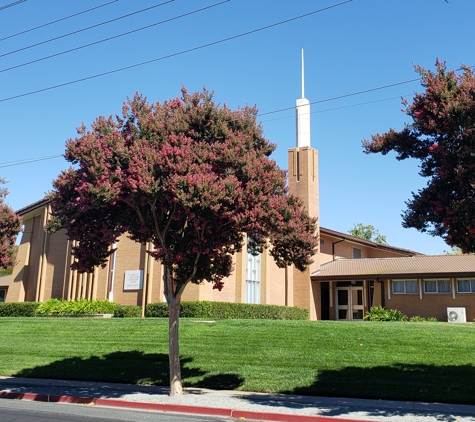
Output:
[0, 52, 475, 321]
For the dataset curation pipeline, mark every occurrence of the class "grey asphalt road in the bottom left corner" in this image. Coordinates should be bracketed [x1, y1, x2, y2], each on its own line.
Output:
[0, 400, 240, 422]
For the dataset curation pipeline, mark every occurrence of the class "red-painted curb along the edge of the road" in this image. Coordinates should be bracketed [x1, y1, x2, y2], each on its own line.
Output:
[0, 391, 370, 422]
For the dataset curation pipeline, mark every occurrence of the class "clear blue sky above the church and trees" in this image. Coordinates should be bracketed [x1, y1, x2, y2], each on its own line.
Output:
[0, 0, 475, 254]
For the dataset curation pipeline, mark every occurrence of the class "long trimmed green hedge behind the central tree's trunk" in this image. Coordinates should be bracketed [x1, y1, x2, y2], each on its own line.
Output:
[145, 301, 309, 320]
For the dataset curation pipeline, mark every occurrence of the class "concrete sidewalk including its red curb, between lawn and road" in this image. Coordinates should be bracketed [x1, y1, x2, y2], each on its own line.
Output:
[0, 377, 475, 422]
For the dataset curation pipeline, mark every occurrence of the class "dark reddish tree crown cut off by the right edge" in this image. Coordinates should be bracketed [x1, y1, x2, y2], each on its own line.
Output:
[363, 60, 475, 253]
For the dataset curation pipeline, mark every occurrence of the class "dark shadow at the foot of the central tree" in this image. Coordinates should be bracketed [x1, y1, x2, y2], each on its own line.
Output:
[14, 351, 244, 397]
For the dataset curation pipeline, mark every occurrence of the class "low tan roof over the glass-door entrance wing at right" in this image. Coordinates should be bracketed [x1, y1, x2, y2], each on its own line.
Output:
[312, 255, 475, 280]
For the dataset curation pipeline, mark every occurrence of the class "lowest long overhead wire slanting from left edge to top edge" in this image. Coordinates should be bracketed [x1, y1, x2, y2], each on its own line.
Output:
[0, 0, 353, 103]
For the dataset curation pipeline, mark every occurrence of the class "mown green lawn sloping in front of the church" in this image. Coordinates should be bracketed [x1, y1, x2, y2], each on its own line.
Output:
[0, 318, 475, 404]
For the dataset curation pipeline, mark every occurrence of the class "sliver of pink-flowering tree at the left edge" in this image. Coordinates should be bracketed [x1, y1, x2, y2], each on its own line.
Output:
[0, 178, 21, 270]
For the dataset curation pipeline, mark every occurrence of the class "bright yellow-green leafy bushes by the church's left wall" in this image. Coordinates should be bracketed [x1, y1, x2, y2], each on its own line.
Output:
[37, 299, 118, 316]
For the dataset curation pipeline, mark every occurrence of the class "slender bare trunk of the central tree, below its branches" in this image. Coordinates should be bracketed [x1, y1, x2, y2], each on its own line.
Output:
[168, 294, 183, 396]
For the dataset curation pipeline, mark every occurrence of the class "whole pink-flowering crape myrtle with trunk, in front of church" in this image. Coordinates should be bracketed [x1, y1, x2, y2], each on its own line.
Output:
[49, 88, 317, 395]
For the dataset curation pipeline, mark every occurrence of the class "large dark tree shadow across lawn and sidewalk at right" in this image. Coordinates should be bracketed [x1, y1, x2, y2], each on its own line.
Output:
[246, 363, 475, 422]
